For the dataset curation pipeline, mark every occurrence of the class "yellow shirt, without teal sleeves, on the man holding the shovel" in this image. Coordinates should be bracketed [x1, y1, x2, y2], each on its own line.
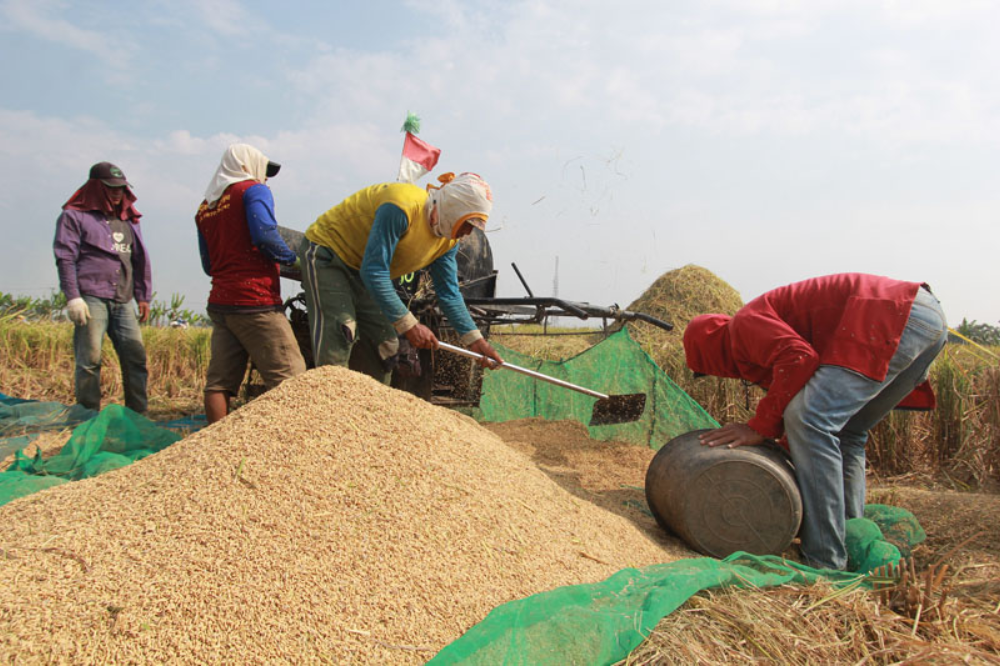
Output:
[306, 183, 458, 280]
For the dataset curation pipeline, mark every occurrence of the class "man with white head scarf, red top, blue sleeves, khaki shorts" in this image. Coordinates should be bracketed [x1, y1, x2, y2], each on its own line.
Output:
[195, 143, 306, 423]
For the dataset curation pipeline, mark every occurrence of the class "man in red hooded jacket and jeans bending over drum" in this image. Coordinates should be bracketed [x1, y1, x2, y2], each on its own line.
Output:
[684, 273, 948, 569]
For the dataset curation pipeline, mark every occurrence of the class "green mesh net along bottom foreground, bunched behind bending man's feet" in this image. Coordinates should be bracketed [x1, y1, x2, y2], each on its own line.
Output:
[428, 506, 923, 666]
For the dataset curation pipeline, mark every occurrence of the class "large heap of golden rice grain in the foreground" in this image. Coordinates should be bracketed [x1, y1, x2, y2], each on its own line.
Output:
[0, 367, 671, 664]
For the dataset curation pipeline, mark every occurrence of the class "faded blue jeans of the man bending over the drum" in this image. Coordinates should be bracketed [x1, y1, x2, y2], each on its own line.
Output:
[784, 289, 948, 569]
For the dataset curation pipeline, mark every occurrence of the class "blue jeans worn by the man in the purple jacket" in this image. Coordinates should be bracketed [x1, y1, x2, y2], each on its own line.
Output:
[73, 295, 148, 414]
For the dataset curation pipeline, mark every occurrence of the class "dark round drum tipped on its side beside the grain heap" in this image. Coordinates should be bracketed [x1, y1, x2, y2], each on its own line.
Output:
[646, 430, 802, 558]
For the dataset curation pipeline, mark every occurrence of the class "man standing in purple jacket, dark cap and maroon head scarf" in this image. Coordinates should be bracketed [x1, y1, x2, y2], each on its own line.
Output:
[52, 162, 153, 414]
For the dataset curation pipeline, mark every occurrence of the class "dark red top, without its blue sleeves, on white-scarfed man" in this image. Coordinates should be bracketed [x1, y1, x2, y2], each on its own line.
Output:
[194, 180, 282, 307]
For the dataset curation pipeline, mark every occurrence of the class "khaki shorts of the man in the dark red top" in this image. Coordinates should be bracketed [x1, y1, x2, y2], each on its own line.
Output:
[205, 310, 306, 395]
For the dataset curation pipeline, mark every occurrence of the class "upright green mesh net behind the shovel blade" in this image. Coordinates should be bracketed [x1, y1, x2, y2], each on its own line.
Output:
[479, 329, 719, 449]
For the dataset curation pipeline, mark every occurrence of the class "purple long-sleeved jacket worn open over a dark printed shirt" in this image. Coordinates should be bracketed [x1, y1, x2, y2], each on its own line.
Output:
[52, 210, 153, 303]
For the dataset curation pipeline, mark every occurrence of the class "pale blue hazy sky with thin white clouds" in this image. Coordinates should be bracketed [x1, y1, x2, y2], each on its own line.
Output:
[0, 0, 1000, 326]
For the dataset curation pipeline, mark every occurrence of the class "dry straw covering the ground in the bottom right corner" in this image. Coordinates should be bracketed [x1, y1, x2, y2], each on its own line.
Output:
[625, 486, 1000, 664]
